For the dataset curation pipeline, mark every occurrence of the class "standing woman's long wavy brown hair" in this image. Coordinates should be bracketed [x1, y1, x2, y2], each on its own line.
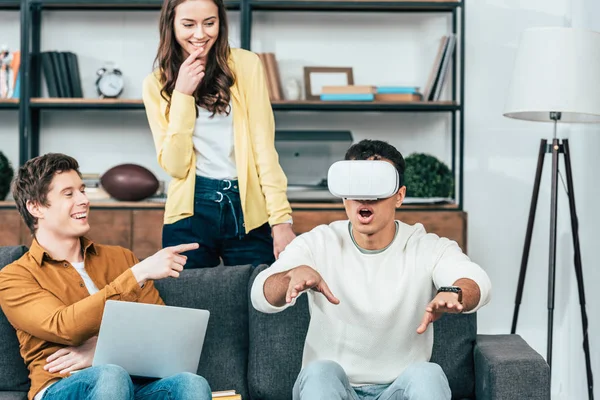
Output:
[154, 0, 235, 116]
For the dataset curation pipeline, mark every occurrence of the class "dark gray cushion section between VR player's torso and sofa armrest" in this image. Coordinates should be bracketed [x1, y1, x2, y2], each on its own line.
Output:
[431, 314, 477, 399]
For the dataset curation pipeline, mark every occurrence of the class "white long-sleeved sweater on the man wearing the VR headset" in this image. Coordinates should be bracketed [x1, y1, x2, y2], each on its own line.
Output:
[251, 221, 491, 386]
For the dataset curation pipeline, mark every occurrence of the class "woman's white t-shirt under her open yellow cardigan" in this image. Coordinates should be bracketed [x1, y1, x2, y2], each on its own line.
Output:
[192, 104, 237, 179]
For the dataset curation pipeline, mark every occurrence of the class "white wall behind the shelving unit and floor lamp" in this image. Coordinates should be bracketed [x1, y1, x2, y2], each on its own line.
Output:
[0, 0, 600, 399]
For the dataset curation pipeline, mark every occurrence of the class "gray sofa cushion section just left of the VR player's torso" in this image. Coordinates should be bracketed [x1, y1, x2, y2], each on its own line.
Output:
[248, 265, 310, 400]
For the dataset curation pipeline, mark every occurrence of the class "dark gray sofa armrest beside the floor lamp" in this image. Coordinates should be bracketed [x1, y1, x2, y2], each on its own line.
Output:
[474, 335, 550, 400]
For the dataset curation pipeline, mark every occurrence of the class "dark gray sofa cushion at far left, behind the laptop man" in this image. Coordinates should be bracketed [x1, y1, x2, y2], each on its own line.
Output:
[0, 246, 30, 392]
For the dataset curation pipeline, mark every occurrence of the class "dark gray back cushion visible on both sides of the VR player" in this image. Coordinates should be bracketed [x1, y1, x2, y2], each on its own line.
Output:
[248, 266, 477, 400]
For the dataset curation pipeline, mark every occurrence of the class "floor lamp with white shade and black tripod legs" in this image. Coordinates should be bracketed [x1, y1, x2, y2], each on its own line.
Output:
[504, 28, 600, 399]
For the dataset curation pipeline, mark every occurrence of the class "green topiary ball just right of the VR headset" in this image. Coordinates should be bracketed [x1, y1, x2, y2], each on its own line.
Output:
[404, 153, 454, 198]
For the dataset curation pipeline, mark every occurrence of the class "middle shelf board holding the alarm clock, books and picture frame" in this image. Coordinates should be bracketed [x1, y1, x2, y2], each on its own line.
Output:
[31, 98, 460, 112]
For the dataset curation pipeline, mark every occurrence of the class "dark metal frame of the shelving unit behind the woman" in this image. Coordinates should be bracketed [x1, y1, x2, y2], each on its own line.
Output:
[10, 0, 465, 211]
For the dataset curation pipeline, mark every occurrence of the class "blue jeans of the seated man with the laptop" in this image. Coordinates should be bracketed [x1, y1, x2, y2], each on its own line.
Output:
[42, 365, 212, 400]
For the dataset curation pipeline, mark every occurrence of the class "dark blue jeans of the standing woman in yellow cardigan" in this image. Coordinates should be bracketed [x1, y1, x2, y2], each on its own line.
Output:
[162, 176, 275, 269]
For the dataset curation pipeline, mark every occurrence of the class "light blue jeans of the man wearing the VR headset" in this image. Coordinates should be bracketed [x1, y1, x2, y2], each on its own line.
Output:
[293, 360, 452, 400]
